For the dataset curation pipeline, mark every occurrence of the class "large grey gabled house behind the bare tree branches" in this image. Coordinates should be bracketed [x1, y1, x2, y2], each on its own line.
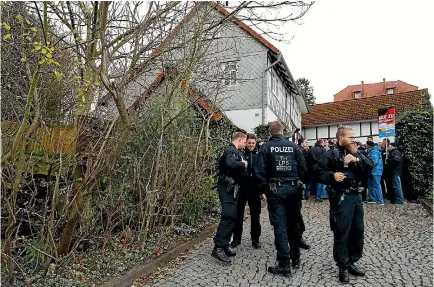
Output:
[98, 2, 309, 135]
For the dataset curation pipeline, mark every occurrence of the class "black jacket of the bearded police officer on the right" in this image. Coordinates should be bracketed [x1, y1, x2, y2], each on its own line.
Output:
[314, 145, 374, 190]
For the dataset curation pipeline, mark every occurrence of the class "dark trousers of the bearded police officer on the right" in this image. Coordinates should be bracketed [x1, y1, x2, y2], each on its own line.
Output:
[330, 193, 364, 269]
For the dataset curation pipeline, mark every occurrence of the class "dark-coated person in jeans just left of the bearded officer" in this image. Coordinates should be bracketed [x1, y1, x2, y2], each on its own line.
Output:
[307, 139, 327, 201]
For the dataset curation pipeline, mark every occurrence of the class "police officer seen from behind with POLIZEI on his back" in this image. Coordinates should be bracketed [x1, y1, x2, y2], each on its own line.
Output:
[254, 121, 307, 276]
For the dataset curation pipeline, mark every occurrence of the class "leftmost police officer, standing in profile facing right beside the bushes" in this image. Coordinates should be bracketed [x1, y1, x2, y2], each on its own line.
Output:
[211, 132, 248, 263]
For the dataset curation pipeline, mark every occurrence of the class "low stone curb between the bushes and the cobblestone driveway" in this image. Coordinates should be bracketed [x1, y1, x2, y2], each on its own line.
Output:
[103, 223, 218, 287]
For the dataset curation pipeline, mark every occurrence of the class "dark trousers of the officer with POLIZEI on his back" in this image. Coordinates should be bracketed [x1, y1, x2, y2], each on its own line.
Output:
[267, 184, 300, 266]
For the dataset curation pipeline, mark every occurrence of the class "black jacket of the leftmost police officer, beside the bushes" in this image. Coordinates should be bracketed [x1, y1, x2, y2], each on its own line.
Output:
[219, 143, 246, 183]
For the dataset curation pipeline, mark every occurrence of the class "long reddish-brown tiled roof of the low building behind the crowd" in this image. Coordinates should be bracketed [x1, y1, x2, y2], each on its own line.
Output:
[302, 89, 428, 127]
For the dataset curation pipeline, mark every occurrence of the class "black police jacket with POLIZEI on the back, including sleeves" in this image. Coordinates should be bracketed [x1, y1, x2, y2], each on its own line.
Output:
[253, 135, 307, 184]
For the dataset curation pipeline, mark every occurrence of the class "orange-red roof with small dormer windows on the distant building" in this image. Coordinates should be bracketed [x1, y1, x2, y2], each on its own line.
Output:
[333, 78, 418, 102]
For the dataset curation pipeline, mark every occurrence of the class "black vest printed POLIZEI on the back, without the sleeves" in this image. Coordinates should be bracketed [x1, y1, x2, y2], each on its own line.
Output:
[266, 140, 298, 182]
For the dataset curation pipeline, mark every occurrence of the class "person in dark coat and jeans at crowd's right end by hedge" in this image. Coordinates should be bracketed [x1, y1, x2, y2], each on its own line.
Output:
[385, 143, 404, 204]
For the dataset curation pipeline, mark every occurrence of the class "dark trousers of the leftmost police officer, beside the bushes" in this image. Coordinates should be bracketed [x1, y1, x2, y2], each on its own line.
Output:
[214, 185, 237, 248]
